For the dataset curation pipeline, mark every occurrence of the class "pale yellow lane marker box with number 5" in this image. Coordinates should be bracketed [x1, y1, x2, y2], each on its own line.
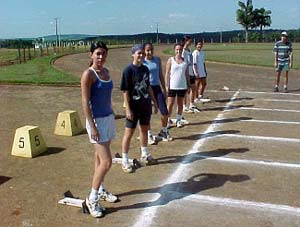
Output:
[11, 125, 47, 158]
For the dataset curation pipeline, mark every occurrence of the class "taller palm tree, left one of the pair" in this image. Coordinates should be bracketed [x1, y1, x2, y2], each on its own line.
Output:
[236, 0, 253, 43]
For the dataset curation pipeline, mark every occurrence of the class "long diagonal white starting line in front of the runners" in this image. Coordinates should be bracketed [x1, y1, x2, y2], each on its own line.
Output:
[133, 91, 239, 227]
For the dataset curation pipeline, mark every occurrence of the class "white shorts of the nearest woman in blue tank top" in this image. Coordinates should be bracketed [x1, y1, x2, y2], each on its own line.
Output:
[85, 114, 116, 144]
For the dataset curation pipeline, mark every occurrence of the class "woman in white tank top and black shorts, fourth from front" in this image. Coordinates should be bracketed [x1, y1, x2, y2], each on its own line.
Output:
[165, 43, 190, 128]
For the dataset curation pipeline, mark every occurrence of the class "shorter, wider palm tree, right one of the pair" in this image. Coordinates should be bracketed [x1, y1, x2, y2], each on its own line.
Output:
[251, 8, 272, 39]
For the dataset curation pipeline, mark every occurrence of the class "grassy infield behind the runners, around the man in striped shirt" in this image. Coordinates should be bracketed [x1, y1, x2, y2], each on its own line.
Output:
[164, 43, 300, 70]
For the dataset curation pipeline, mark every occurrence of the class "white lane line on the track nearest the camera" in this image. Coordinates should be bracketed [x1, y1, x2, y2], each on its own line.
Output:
[177, 192, 300, 216]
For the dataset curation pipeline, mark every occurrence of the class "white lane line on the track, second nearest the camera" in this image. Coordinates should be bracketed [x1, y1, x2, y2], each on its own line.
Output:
[196, 154, 300, 169]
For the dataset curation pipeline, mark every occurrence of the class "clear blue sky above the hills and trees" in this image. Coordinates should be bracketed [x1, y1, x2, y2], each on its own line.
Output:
[0, 0, 300, 39]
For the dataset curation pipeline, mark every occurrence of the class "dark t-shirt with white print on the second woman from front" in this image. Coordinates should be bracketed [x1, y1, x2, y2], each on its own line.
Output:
[120, 64, 151, 111]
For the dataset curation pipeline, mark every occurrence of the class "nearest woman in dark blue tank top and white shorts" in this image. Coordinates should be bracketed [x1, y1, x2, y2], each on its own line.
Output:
[81, 42, 118, 217]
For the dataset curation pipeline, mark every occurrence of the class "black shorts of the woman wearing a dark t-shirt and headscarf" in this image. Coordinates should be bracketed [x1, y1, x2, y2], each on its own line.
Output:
[125, 99, 152, 128]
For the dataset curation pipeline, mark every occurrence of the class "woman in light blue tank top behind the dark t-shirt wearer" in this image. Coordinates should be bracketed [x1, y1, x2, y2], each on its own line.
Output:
[143, 43, 172, 144]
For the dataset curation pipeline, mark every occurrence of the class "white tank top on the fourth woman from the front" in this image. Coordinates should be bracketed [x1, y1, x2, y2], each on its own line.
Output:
[170, 57, 187, 90]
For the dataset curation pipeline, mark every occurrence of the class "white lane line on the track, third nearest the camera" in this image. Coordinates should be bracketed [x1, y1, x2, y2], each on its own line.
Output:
[220, 134, 300, 143]
